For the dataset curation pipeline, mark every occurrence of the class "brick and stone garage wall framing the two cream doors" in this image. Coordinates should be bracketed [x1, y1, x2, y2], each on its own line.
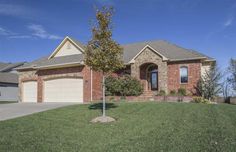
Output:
[19, 66, 102, 102]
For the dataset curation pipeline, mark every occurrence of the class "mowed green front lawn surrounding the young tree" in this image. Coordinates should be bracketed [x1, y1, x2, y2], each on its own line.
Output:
[0, 102, 236, 152]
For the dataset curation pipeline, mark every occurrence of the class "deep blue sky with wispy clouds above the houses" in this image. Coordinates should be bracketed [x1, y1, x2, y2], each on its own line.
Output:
[0, 0, 236, 68]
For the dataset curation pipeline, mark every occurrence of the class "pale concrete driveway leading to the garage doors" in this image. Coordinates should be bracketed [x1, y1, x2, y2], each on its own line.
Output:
[0, 103, 78, 121]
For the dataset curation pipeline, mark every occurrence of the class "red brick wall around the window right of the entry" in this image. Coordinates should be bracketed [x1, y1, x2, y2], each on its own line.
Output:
[168, 61, 201, 93]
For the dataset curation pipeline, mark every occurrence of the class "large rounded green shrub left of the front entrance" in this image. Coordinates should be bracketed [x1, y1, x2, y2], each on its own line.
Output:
[106, 75, 143, 96]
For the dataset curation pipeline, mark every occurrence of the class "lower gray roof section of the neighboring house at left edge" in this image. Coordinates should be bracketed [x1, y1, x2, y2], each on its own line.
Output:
[0, 72, 18, 84]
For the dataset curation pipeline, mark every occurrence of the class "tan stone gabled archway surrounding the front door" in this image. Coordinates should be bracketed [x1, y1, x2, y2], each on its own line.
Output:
[131, 47, 168, 92]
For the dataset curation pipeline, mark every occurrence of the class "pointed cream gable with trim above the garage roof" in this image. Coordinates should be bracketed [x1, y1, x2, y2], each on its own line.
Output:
[48, 36, 84, 59]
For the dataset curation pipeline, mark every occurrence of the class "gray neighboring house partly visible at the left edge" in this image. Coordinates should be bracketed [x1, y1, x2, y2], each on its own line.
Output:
[0, 62, 24, 102]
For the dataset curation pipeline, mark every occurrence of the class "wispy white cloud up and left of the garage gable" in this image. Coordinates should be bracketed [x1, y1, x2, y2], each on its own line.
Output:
[27, 24, 62, 40]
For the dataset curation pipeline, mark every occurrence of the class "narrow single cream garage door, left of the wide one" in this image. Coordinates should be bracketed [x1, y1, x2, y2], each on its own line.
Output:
[22, 81, 37, 102]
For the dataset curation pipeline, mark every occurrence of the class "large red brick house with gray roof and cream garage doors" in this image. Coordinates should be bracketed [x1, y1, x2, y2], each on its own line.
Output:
[17, 37, 215, 102]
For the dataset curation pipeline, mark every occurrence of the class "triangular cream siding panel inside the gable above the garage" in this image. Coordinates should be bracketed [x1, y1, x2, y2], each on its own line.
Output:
[54, 41, 82, 57]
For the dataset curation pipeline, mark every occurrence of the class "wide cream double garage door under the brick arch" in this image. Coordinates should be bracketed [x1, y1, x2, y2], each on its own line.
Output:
[44, 78, 83, 102]
